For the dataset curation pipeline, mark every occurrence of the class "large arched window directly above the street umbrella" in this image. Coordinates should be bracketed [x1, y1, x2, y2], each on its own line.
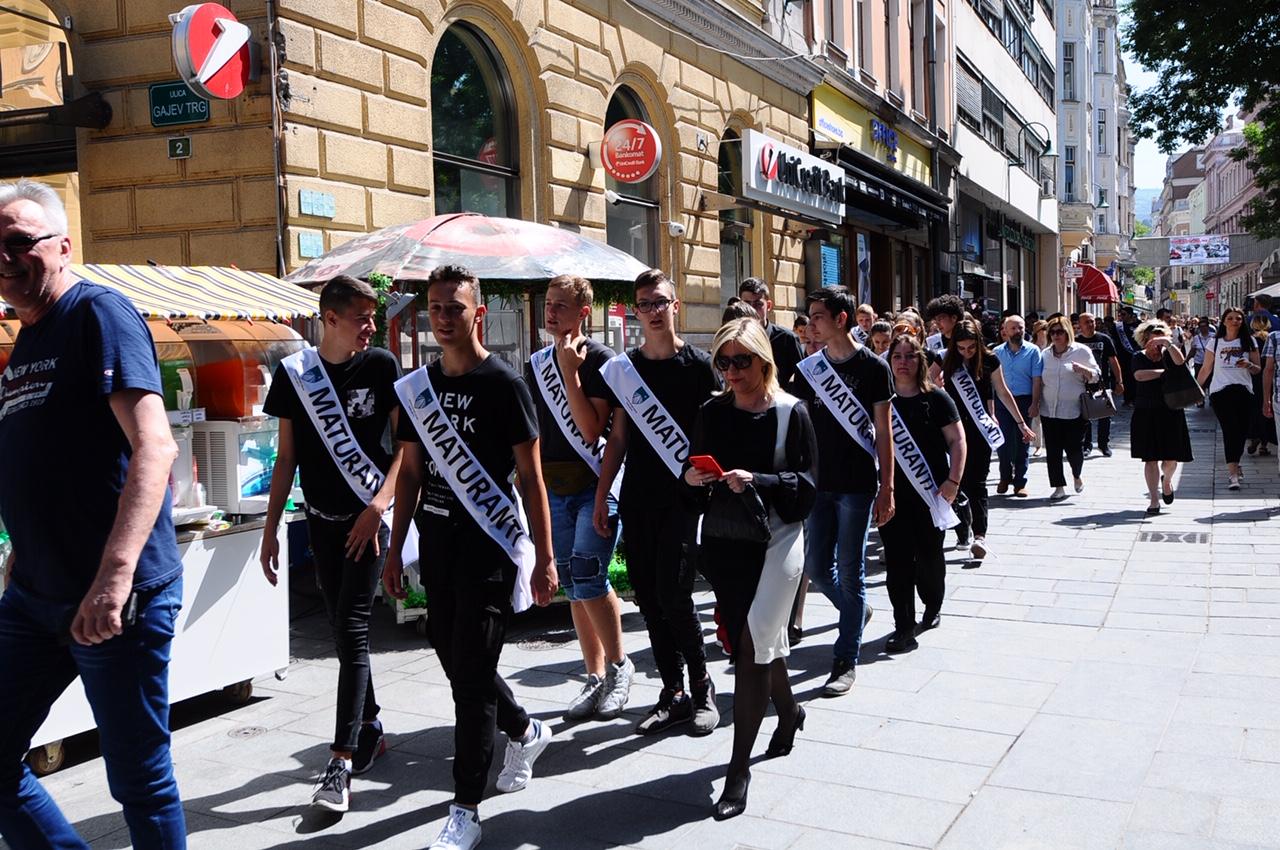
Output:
[431, 24, 520, 218]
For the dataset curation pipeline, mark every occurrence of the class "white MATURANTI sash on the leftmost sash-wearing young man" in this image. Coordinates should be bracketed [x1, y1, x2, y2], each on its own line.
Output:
[280, 348, 387, 504]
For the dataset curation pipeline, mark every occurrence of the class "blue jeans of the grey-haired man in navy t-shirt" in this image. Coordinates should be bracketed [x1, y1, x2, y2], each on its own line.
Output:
[0, 577, 187, 850]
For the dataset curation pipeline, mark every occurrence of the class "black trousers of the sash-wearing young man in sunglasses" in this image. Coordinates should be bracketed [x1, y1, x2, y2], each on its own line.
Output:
[618, 499, 707, 690]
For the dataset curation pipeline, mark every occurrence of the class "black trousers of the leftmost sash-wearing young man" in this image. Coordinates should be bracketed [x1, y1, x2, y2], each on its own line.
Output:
[307, 513, 390, 753]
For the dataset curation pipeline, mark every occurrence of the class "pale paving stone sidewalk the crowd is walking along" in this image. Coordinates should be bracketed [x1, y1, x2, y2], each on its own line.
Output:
[17, 410, 1280, 850]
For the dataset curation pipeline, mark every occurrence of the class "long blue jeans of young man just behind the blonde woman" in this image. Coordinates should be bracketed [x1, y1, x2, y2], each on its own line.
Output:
[804, 490, 876, 664]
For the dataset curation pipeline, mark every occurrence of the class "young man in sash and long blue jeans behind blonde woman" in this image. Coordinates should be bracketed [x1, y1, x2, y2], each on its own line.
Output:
[795, 287, 893, 696]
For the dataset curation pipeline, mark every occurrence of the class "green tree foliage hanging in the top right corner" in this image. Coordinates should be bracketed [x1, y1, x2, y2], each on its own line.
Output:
[1124, 0, 1280, 238]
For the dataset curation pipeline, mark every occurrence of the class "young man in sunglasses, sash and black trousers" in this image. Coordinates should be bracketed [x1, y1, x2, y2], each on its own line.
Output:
[586, 269, 719, 735]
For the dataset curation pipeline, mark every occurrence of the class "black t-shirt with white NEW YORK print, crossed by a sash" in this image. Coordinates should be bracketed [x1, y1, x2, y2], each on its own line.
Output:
[396, 353, 538, 520]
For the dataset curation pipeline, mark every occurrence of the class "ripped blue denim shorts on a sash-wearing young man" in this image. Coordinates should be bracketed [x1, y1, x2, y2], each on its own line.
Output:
[547, 485, 618, 602]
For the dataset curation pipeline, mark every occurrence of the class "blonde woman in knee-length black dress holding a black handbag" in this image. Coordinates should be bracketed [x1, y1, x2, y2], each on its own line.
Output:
[1129, 321, 1192, 515]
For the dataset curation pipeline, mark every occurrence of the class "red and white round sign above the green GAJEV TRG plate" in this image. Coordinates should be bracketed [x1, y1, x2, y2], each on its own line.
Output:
[170, 3, 252, 100]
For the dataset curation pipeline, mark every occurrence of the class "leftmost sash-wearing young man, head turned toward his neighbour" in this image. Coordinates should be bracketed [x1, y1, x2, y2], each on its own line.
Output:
[260, 277, 399, 812]
